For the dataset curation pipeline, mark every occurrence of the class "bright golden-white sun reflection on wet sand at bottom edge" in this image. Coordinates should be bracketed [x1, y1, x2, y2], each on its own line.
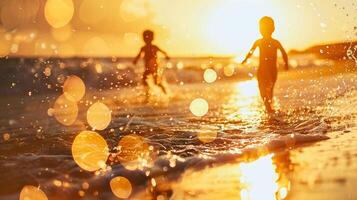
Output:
[168, 154, 289, 200]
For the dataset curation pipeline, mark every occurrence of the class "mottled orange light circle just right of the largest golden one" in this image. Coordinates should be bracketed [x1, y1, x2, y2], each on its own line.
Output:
[117, 135, 153, 170]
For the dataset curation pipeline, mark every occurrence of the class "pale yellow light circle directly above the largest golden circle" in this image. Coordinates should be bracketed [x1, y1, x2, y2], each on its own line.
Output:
[87, 102, 112, 130]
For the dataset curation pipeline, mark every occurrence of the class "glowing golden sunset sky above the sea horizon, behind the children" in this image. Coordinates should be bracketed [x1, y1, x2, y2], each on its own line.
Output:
[0, 0, 357, 56]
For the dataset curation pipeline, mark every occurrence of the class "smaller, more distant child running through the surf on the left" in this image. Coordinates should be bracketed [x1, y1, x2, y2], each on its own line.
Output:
[133, 30, 170, 94]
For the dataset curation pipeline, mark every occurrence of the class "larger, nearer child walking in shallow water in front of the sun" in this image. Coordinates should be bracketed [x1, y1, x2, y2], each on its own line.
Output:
[242, 17, 288, 113]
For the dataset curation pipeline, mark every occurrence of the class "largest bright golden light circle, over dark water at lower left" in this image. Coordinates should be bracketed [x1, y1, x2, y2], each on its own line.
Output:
[72, 131, 109, 171]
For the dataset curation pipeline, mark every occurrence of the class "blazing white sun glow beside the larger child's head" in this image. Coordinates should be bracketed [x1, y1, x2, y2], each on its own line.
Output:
[204, 0, 273, 57]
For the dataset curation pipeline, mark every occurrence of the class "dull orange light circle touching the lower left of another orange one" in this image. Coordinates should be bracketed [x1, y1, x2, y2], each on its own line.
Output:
[50, 95, 78, 126]
